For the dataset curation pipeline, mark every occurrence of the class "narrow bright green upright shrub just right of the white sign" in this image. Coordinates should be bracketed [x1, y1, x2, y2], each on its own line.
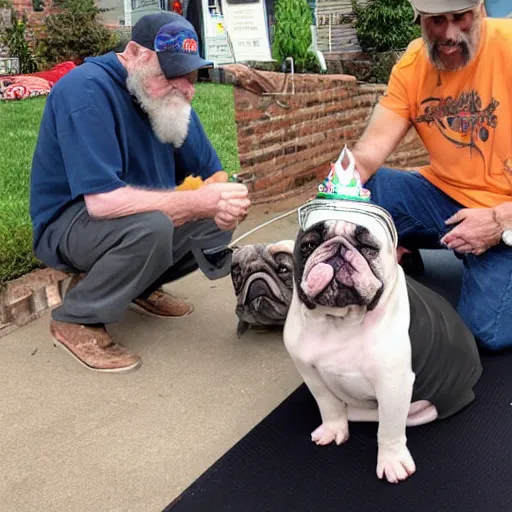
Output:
[272, 0, 318, 73]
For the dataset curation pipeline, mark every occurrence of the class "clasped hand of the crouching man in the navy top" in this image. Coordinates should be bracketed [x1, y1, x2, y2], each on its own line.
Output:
[198, 183, 251, 231]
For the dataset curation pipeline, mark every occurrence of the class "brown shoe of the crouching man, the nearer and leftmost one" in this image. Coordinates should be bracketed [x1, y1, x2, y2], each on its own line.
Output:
[50, 320, 142, 373]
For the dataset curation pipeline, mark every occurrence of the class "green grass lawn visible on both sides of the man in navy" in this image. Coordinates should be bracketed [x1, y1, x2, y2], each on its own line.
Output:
[0, 83, 239, 283]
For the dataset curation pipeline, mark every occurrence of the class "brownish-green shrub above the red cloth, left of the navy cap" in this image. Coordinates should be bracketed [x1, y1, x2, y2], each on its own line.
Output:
[37, 0, 119, 68]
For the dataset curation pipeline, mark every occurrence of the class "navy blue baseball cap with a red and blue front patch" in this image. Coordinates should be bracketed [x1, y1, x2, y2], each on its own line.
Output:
[131, 11, 213, 78]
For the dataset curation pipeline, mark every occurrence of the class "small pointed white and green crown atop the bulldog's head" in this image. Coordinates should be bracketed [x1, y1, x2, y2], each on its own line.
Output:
[317, 146, 371, 201]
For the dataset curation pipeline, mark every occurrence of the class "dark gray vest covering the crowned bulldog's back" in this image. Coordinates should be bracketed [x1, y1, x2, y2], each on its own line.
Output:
[406, 276, 482, 419]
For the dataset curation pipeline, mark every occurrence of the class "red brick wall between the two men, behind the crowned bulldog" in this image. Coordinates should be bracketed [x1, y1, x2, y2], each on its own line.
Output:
[224, 65, 428, 203]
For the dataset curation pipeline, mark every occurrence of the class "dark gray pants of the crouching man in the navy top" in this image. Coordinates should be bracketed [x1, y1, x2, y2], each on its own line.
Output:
[48, 206, 233, 324]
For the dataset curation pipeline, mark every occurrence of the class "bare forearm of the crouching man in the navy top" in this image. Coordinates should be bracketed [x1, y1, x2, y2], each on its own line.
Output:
[85, 186, 209, 226]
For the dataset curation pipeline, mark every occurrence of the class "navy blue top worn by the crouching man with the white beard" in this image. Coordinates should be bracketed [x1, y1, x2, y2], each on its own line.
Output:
[30, 52, 222, 268]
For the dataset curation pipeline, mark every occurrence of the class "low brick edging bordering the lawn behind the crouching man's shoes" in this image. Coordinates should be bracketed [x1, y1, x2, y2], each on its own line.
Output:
[0, 268, 71, 338]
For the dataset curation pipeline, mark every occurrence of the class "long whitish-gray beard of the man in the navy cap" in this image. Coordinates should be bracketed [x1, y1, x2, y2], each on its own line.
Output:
[126, 73, 192, 148]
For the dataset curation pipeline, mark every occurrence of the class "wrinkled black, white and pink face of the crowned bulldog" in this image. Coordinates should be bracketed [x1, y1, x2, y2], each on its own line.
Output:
[294, 220, 396, 315]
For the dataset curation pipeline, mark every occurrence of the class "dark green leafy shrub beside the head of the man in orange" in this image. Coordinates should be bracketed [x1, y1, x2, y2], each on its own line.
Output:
[352, 0, 421, 52]
